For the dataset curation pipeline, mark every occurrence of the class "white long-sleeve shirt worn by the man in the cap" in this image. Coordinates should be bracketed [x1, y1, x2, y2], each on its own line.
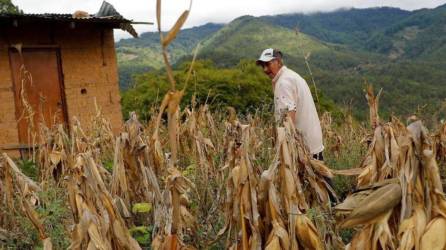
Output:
[273, 66, 324, 154]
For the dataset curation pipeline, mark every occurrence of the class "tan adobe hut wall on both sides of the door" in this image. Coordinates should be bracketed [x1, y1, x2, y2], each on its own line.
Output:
[0, 23, 123, 152]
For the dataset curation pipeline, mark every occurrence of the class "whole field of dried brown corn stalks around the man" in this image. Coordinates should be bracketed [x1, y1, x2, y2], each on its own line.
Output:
[0, 1, 446, 250]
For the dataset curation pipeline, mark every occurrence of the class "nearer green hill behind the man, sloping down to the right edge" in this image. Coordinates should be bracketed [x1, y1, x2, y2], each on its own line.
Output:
[195, 14, 446, 118]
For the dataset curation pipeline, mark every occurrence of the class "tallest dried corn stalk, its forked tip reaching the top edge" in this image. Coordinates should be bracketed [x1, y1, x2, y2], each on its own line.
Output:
[152, 0, 196, 249]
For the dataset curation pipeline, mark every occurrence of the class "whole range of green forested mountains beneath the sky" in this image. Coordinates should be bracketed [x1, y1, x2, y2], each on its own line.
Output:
[117, 3, 446, 121]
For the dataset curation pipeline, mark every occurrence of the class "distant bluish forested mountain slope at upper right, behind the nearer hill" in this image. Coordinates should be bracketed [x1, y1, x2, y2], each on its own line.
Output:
[261, 5, 446, 60]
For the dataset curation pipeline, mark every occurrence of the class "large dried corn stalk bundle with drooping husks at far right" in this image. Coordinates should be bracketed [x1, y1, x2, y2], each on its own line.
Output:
[336, 91, 446, 249]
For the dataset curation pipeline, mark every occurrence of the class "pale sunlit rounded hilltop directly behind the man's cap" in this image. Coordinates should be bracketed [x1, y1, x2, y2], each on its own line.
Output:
[200, 16, 331, 66]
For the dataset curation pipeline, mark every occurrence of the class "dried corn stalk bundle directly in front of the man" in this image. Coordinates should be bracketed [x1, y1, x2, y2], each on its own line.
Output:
[259, 128, 324, 249]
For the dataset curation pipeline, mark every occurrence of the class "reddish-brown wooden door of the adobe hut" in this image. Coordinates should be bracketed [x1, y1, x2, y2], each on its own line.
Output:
[9, 48, 67, 145]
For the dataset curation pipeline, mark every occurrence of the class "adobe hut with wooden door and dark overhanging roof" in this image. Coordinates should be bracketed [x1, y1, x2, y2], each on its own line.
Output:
[0, 2, 136, 151]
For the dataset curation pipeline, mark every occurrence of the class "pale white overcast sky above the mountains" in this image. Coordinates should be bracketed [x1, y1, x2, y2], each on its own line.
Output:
[12, 0, 446, 39]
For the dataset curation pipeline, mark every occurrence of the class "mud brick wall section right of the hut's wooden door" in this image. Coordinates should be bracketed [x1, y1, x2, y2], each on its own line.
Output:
[57, 28, 122, 132]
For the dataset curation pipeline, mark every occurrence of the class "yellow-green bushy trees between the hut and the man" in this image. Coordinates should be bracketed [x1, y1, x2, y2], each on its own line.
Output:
[122, 61, 272, 119]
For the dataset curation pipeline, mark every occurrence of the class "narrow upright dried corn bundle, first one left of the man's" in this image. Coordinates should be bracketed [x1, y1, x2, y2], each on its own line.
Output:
[218, 120, 262, 249]
